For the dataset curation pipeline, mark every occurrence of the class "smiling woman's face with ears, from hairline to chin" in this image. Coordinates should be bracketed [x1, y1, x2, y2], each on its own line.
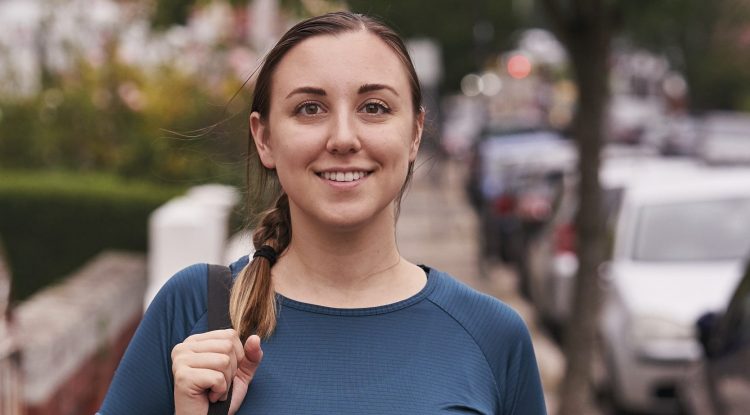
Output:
[251, 31, 424, 229]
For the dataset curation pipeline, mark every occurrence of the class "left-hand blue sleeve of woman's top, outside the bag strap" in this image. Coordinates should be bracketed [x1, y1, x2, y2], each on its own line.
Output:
[97, 264, 207, 415]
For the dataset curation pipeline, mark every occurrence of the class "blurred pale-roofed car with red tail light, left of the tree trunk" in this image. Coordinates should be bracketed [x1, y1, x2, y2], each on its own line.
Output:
[467, 125, 575, 263]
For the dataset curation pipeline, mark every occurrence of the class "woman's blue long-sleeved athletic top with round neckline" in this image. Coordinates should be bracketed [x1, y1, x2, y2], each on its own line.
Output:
[100, 257, 546, 415]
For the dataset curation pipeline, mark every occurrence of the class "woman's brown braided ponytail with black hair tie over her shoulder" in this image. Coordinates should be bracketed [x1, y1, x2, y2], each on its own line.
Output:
[229, 193, 292, 341]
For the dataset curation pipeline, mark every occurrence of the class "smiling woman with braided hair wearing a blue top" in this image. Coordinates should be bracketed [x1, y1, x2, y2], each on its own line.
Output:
[101, 12, 545, 415]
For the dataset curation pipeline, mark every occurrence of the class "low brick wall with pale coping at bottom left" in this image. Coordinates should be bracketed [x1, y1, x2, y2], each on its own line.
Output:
[13, 252, 146, 415]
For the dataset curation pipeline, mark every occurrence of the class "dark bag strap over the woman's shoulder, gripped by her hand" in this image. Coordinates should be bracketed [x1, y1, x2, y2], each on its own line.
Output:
[207, 264, 232, 415]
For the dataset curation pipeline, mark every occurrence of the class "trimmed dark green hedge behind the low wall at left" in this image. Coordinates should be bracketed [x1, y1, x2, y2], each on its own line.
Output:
[0, 170, 183, 300]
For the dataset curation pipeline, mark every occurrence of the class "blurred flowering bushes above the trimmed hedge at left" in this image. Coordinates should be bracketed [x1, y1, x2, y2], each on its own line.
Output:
[0, 48, 248, 184]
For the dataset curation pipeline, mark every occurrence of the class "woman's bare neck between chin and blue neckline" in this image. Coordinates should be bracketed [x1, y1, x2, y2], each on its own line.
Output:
[272, 206, 426, 308]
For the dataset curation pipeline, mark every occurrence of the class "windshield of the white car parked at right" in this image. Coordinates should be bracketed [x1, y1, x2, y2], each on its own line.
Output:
[633, 199, 750, 261]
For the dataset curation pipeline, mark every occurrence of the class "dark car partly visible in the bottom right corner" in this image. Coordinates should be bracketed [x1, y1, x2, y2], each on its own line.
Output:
[679, 259, 750, 415]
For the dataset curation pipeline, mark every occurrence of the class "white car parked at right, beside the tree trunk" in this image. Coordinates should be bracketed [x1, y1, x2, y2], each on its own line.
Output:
[600, 167, 750, 413]
